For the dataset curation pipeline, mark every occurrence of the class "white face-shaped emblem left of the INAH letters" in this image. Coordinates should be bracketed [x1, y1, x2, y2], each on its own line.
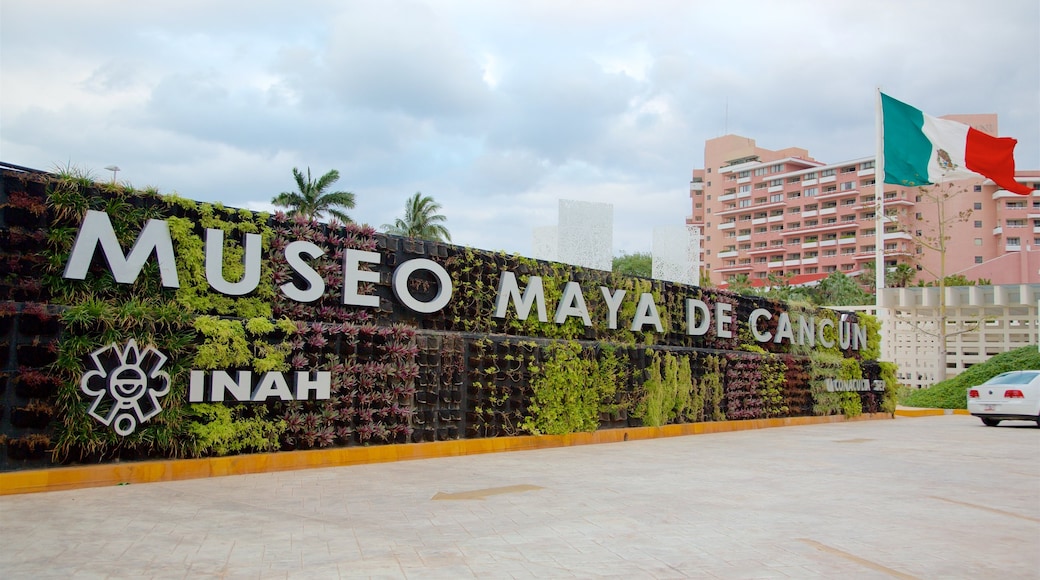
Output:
[79, 339, 170, 436]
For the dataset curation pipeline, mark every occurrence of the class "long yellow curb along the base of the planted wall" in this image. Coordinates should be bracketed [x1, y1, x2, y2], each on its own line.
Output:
[0, 413, 892, 496]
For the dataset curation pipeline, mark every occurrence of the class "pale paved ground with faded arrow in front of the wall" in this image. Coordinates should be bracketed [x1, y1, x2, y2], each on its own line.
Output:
[0, 416, 1040, 579]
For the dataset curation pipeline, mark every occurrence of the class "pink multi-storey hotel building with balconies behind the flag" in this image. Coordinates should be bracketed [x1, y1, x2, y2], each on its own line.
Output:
[686, 114, 1040, 285]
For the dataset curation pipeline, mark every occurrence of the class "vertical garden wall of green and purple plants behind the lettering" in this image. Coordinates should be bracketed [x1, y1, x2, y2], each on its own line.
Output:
[0, 169, 895, 470]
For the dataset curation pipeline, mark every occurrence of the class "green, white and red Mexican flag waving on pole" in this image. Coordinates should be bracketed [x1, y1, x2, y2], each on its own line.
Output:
[881, 93, 1033, 195]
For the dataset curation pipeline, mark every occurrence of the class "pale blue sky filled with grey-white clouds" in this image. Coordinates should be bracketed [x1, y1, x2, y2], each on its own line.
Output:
[0, 0, 1040, 254]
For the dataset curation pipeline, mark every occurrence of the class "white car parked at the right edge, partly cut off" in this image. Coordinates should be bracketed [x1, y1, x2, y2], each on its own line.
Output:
[968, 370, 1040, 427]
